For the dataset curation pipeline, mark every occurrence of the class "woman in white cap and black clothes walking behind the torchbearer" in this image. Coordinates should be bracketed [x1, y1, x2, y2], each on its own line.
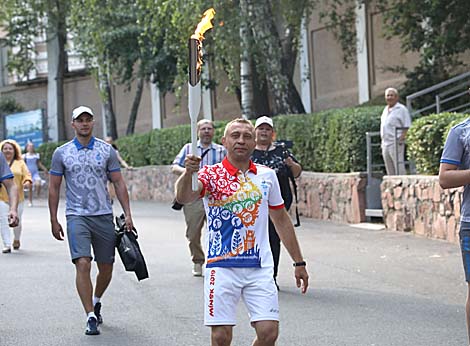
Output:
[251, 116, 302, 289]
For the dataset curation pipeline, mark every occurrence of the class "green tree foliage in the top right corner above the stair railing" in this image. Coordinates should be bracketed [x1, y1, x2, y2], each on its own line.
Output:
[320, 0, 470, 98]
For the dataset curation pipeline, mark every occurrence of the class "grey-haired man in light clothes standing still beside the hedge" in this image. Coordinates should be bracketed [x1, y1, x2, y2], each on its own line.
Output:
[380, 88, 411, 175]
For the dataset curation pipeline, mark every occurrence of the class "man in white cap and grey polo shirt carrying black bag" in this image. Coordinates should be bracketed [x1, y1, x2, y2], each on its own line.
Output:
[49, 106, 134, 335]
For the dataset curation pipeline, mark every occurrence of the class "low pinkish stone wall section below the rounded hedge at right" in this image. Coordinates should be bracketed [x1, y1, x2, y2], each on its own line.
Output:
[381, 175, 463, 242]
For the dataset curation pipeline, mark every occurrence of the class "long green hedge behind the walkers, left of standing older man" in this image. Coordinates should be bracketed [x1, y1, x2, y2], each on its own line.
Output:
[34, 107, 383, 173]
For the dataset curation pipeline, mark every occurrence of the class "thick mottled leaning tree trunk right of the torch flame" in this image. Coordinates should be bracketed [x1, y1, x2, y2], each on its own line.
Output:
[240, 0, 305, 114]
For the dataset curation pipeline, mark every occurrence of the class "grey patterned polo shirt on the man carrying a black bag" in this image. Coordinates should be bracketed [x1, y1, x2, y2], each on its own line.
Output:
[49, 137, 121, 216]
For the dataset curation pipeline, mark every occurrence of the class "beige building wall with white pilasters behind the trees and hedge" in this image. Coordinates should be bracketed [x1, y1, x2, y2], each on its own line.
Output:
[0, 5, 434, 139]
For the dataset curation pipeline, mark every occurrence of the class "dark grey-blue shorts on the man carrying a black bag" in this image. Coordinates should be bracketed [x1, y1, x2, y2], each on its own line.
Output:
[67, 214, 116, 263]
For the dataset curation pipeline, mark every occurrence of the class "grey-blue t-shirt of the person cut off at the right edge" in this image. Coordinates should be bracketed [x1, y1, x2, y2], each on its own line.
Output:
[441, 118, 470, 222]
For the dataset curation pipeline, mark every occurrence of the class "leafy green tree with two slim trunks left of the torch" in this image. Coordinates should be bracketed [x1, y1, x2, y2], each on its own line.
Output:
[71, 0, 185, 137]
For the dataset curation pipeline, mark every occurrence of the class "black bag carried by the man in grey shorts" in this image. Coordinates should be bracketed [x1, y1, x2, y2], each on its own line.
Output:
[116, 214, 149, 281]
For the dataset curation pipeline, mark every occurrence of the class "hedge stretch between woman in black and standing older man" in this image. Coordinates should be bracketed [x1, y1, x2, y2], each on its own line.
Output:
[274, 107, 383, 173]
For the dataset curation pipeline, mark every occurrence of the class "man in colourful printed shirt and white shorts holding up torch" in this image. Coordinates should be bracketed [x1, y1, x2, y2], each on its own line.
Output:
[176, 119, 308, 346]
